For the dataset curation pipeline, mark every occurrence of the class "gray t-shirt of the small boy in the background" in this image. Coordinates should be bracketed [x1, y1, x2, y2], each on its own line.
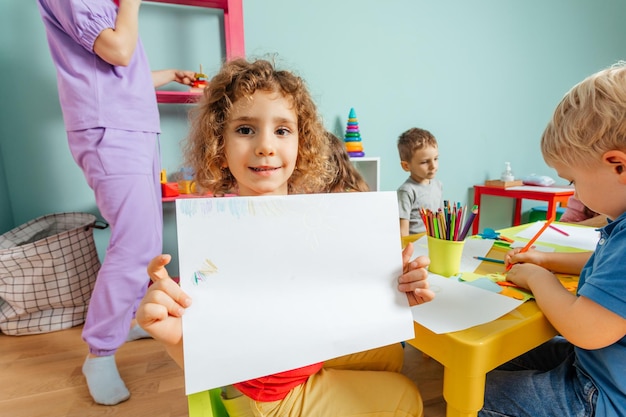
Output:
[398, 177, 443, 235]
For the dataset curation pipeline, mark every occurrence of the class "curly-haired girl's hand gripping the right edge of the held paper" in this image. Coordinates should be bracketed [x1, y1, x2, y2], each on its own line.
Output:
[398, 243, 435, 306]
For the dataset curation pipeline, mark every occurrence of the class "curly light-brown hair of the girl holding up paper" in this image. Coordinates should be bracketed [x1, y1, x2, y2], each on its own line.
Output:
[184, 59, 333, 195]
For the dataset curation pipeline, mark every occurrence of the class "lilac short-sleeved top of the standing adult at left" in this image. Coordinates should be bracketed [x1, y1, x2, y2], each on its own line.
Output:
[38, 0, 160, 133]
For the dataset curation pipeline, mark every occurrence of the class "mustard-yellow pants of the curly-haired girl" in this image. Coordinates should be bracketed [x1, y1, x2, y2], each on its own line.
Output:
[225, 343, 423, 417]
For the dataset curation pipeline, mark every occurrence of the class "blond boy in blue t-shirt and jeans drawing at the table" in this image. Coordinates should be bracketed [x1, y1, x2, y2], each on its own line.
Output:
[479, 63, 626, 417]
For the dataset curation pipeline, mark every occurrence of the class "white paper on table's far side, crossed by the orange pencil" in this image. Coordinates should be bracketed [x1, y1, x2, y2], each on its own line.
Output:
[515, 221, 600, 251]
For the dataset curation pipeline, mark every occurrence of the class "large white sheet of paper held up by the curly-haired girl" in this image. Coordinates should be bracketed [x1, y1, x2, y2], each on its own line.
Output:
[176, 192, 414, 394]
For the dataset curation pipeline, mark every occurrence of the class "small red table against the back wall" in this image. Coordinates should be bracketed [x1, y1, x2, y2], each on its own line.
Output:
[472, 185, 574, 234]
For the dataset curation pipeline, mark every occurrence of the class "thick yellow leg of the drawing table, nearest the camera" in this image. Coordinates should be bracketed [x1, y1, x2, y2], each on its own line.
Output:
[443, 368, 485, 417]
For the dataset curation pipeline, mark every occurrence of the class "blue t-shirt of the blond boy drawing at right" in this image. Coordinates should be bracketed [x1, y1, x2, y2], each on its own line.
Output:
[576, 213, 626, 417]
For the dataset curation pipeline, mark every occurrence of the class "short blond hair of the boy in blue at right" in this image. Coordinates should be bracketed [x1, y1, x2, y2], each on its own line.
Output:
[541, 62, 626, 166]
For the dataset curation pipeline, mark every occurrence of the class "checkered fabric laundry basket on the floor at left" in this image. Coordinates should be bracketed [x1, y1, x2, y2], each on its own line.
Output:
[0, 212, 108, 336]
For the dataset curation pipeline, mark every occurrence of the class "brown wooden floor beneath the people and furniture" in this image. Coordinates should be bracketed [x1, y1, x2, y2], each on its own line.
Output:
[0, 326, 445, 417]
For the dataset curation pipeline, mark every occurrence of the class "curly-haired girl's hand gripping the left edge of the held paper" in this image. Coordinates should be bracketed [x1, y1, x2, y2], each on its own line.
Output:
[136, 255, 191, 345]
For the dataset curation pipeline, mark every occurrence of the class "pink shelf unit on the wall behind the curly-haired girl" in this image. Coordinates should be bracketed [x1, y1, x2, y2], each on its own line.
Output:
[148, 0, 246, 104]
